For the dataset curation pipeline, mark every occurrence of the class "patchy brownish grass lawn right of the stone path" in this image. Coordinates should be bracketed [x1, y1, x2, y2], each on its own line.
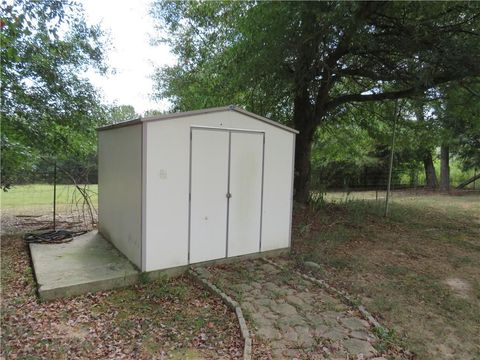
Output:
[293, 193, 480, 359]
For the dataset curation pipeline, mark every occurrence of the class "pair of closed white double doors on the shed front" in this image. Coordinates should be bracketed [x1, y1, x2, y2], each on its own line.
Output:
[189, 127, 265, 263]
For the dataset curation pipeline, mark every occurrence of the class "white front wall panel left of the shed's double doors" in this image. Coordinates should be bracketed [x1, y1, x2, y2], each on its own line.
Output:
[145, 121, 190, 271]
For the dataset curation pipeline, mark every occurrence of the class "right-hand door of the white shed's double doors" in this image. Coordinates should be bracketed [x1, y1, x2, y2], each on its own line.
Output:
[228, 132, 264, 256]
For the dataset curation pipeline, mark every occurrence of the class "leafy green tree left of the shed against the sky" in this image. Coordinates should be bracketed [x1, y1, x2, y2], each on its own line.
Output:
[0, 0, 105, 186]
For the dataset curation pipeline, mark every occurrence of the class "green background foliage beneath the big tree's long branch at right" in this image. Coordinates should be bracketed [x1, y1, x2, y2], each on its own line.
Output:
[312, 88, 480, 189]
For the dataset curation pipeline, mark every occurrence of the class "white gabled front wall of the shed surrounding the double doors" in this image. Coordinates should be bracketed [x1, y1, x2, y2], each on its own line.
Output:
[144, 111, 295, 271]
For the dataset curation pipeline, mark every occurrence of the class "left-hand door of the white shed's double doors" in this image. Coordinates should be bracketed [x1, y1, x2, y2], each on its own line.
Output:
[190, 129, 229, 263]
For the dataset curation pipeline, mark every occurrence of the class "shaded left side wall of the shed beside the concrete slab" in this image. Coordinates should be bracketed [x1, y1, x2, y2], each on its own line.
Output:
[98, 125, 142, 268]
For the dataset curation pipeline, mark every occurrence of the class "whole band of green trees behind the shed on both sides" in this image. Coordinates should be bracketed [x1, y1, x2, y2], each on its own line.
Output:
[1, 0, 480, 202]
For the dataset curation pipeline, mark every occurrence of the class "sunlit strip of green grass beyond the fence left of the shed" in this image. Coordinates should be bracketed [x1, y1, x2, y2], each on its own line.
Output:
[1, 184, 97, 209]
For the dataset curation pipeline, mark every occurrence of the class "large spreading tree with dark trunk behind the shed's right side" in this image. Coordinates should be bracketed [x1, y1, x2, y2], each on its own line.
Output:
[152, 1, 480, 202]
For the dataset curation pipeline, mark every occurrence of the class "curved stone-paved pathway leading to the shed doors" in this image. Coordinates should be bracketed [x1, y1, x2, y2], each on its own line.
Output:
[197, 259, 379, 359]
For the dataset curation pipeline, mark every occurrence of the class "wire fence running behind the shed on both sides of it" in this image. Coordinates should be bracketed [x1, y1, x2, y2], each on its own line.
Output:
[1, 163, 480, 234]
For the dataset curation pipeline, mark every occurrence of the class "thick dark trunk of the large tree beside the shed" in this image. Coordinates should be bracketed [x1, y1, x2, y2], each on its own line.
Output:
[293, 93, 316, 204]
